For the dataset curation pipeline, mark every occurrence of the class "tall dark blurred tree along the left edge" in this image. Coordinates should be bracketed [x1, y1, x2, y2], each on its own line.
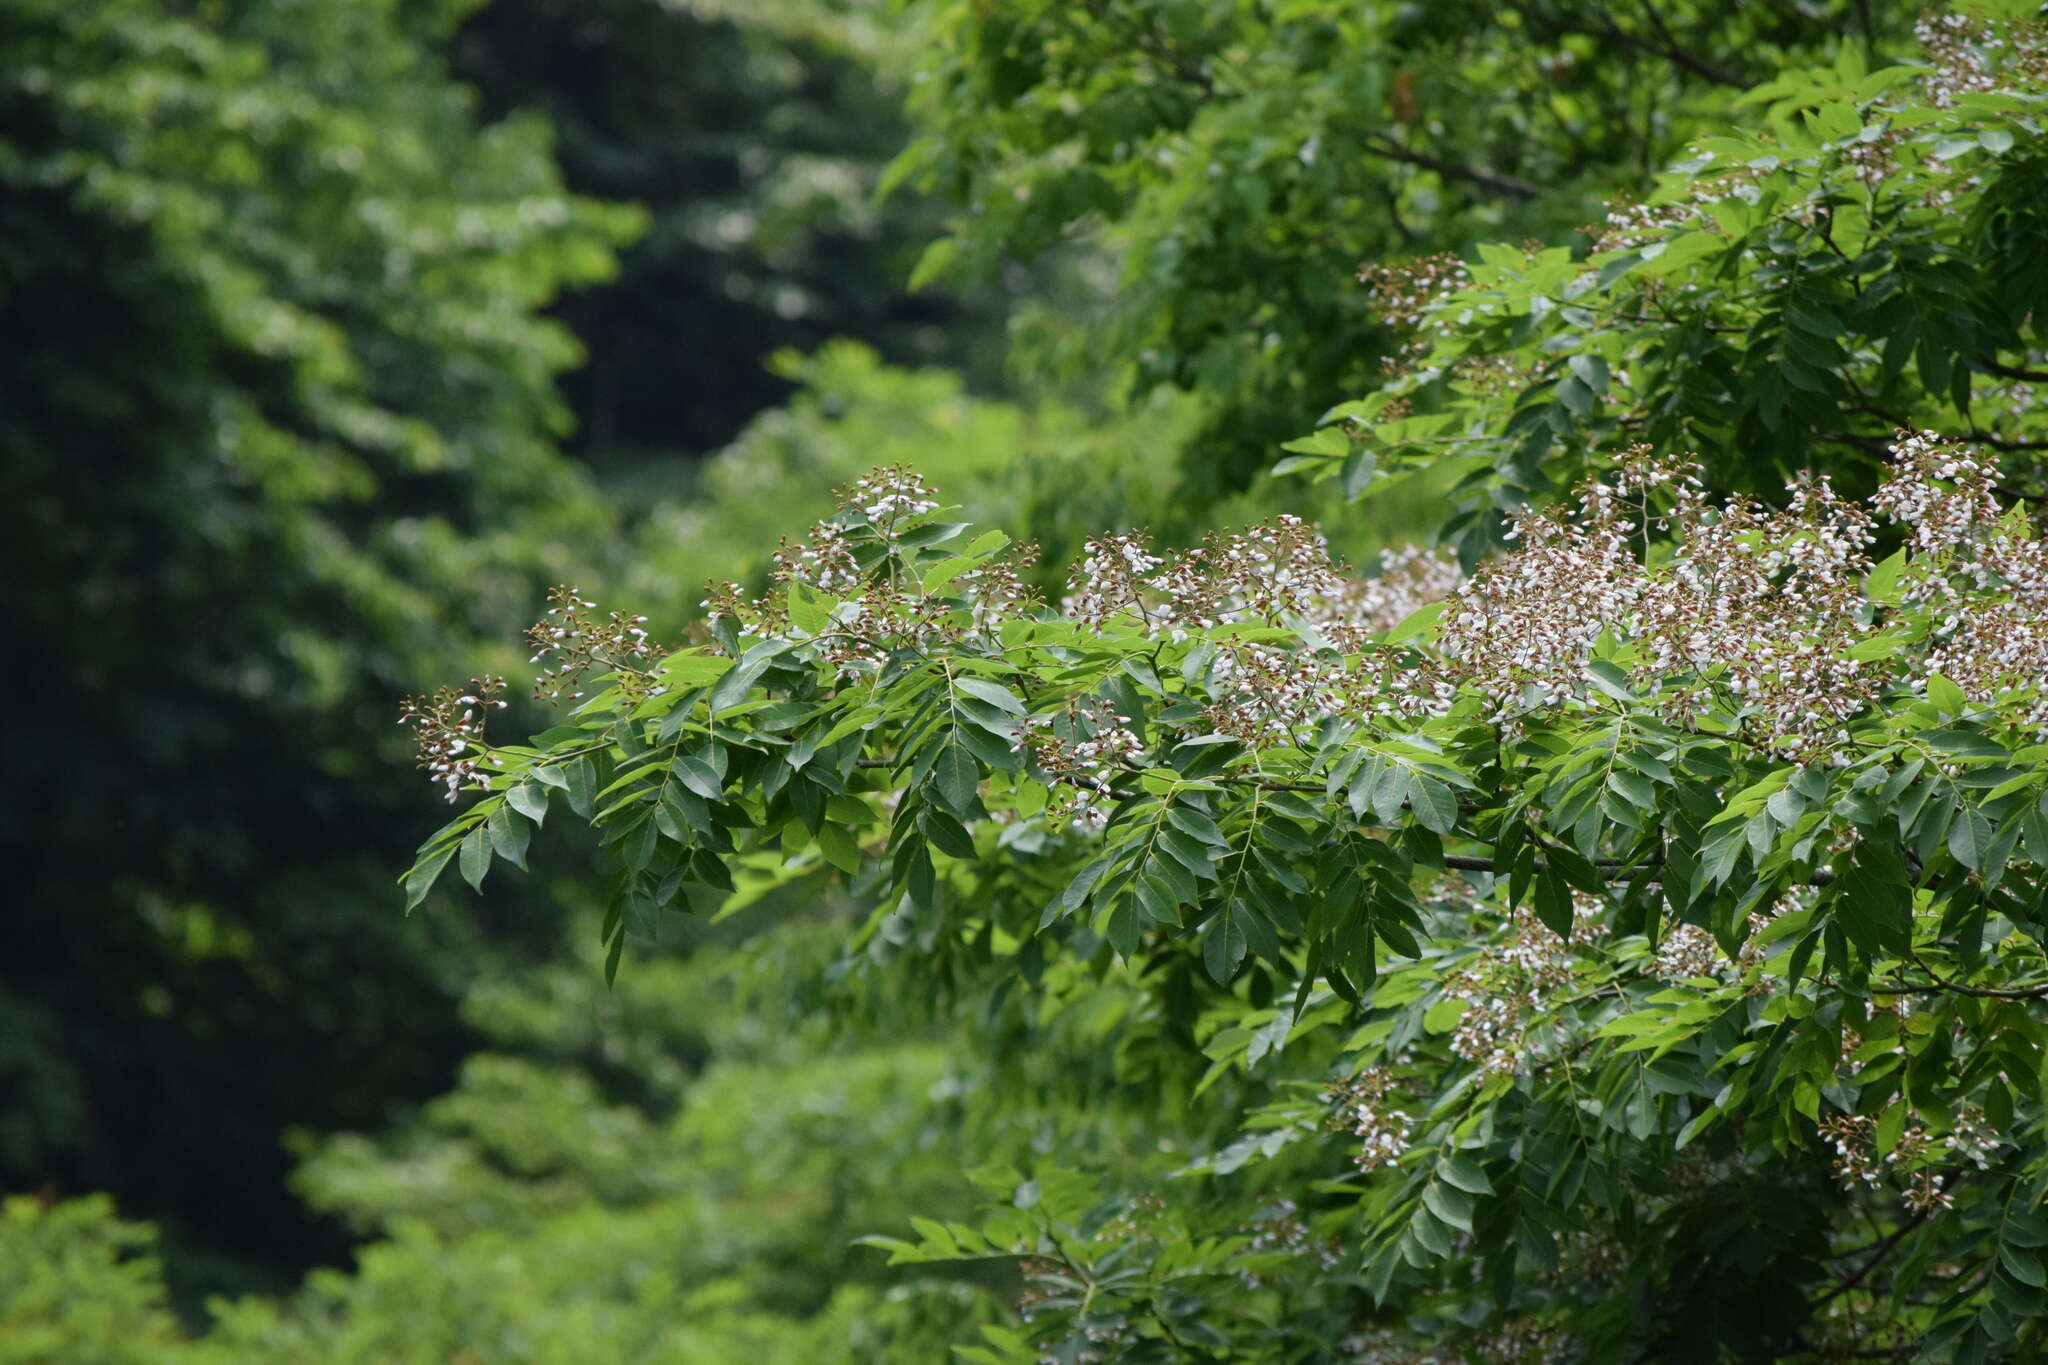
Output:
[0, 0, 635, 1287]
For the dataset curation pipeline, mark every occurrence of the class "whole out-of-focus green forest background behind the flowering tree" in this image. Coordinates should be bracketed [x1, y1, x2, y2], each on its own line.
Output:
[0, 0, 1903, 1361]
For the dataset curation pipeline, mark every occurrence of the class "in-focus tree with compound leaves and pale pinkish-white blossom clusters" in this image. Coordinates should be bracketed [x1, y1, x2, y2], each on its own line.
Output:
[406, 20, 2048, 1363]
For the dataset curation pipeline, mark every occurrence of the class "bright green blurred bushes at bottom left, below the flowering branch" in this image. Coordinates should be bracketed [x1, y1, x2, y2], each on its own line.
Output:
[0, 941, 995, 1365]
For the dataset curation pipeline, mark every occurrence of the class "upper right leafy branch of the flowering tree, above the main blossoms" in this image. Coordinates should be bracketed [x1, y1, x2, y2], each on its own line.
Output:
[1290, 9, 2048, 559]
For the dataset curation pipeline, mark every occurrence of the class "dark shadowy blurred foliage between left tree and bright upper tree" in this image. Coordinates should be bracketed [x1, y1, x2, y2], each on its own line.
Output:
[451, 0, 1001, 464]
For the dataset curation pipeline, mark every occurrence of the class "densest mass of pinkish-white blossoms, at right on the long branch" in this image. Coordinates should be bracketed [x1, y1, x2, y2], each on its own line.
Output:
[1425, 434, 2048, 755]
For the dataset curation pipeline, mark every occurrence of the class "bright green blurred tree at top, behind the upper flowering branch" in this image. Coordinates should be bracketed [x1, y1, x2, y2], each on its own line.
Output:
[891, 0, 1896, 501]
